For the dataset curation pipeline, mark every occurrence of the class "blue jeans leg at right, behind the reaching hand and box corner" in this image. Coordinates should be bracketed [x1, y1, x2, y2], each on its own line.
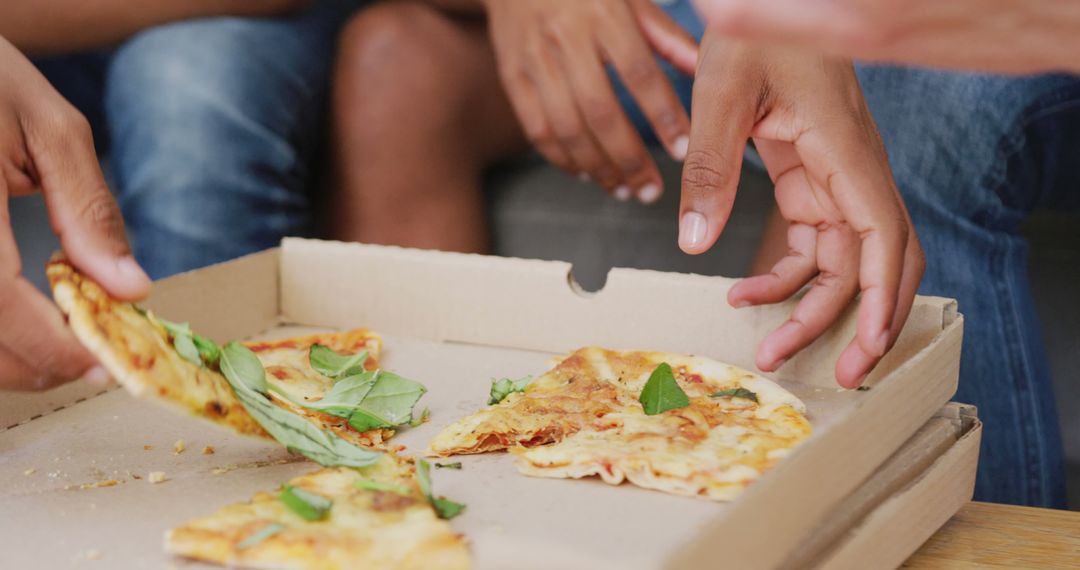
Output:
[639, 0, 1080, 507]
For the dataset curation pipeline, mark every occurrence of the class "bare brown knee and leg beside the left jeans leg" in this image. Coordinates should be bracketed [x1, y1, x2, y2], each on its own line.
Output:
[329, 2, 528, 253]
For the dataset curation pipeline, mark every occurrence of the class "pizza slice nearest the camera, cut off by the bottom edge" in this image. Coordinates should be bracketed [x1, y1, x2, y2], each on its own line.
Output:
[165, 454, 470, 570]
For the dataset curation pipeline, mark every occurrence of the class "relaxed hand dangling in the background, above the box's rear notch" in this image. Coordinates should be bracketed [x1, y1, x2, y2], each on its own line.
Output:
[485, 0, 697, 203]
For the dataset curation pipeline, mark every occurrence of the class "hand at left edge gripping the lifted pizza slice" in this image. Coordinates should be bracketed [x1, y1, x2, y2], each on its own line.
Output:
[0, 38, 150, 390]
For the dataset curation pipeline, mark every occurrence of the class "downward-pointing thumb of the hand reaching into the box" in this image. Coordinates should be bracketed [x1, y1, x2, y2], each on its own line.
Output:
[678, 38, 760, 254]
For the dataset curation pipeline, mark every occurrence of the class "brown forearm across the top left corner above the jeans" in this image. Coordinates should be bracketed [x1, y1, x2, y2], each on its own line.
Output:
[0, 0, 308, 54]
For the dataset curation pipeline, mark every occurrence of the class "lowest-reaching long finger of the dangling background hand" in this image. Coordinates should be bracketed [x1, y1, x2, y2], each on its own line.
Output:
[558, 28, 663, 204]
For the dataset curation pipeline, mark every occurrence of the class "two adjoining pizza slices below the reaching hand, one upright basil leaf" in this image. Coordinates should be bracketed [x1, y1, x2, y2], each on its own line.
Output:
[431, 348, 811, 500]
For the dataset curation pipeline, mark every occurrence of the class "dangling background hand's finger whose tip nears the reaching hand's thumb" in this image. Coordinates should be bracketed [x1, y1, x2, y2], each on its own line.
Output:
[597, 0, 690, 166]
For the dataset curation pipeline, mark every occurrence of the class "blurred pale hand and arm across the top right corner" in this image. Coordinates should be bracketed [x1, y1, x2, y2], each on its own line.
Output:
[694, 0, 1080, 72]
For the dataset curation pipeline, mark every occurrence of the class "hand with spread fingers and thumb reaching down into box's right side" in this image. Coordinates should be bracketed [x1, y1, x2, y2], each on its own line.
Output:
[679, 29, 924, 388]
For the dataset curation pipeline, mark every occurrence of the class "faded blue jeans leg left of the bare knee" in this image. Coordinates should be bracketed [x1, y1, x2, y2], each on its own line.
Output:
[38, 0, 356, 279]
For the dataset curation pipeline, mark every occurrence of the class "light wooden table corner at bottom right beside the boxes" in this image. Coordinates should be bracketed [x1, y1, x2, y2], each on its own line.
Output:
[903, 502, 1080, 569]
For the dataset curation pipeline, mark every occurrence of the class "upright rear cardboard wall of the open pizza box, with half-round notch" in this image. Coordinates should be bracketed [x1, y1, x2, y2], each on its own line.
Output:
[281, 239, 956, 388]
